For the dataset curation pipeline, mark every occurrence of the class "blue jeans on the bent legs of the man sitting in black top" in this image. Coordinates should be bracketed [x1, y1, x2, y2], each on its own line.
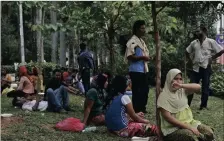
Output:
[47, 86, 69, 112]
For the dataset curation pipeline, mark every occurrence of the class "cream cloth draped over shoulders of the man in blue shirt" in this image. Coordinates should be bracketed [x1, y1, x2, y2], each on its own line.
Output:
[125, 35, 149, 72]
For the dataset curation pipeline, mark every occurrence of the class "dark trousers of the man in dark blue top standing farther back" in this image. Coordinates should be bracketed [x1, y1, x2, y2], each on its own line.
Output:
[81, 69, 90, 93]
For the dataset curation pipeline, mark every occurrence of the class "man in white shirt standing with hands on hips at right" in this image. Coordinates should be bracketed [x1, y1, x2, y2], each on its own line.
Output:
[186, 26, 224, 110]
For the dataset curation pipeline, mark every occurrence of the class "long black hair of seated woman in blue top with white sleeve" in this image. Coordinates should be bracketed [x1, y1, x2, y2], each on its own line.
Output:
[103, 75, 127, 110]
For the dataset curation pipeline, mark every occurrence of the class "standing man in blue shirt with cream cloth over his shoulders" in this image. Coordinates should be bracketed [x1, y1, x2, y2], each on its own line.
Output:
[125, 20, 150, 113]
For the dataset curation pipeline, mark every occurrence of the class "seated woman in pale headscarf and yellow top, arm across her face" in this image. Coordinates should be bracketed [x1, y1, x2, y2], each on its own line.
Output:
[157, 69, 214, 141]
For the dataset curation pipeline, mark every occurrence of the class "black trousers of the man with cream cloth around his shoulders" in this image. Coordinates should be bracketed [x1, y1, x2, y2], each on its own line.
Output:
[129, 72, 149, 113]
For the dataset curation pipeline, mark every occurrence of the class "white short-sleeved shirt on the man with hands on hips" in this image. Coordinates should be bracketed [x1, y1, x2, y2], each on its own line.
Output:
[186, 37, 223, 72]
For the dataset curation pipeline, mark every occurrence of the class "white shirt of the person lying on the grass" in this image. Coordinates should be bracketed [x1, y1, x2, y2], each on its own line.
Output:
[22, 100, 48, 111]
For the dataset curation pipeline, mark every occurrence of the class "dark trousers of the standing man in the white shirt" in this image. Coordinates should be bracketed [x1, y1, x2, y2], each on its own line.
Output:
[188, 65, 212, 107]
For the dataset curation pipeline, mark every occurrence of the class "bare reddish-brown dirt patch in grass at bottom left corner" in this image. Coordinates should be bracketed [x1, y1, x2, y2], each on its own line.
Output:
[1, 117, 23, 129]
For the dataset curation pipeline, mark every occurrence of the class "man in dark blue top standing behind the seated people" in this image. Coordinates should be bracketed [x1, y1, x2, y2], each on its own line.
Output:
[78, 43, 94, 93]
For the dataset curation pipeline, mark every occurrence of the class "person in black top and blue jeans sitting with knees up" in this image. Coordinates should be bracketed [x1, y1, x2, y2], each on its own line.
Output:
[44, 69, 75, 112]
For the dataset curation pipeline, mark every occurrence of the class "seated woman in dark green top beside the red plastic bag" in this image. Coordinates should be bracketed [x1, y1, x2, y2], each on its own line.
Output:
[83, 74, 108, 126]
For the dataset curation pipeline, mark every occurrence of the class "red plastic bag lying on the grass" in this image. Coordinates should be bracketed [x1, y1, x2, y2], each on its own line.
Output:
[55, 117, 84, 132]
